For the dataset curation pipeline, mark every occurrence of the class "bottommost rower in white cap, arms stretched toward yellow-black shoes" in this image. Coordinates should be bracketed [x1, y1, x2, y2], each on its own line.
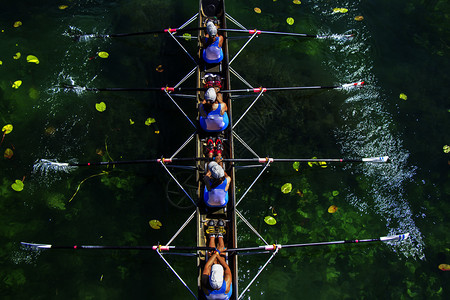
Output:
[202, 220, 233, 300]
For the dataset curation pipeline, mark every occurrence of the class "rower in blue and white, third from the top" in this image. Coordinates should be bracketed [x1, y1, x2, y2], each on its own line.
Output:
[203, 158, 231, 207]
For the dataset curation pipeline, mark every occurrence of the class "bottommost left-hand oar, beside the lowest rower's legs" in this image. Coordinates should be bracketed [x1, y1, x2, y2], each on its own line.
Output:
[21, 242, 215, 251]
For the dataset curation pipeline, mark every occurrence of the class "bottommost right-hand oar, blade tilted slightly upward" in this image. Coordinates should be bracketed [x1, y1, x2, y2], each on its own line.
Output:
[226, 233, 409, 252]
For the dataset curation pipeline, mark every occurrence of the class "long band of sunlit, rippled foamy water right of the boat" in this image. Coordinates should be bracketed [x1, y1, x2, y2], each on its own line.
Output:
[315, 2, 424, 259]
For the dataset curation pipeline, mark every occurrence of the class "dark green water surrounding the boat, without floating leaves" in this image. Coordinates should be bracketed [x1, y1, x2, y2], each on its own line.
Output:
[0, 0, 450, 299]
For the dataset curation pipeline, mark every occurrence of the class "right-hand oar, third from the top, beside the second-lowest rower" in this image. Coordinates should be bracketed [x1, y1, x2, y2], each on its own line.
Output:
[223, 156, 389, 163]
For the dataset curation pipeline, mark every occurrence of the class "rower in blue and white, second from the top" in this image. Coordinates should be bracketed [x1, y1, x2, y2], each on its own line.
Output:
[198, 87, 230, 132]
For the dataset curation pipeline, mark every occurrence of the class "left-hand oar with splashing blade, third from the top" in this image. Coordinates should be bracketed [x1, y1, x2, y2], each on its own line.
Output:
[33, 157, 206, 172]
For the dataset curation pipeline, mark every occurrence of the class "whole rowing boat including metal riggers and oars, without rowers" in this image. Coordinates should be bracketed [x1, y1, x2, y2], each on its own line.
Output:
[23, 0, 408, 299]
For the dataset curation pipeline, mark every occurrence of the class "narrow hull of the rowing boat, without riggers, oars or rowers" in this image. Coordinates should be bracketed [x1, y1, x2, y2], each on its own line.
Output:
[196, 0, 238, 299]
